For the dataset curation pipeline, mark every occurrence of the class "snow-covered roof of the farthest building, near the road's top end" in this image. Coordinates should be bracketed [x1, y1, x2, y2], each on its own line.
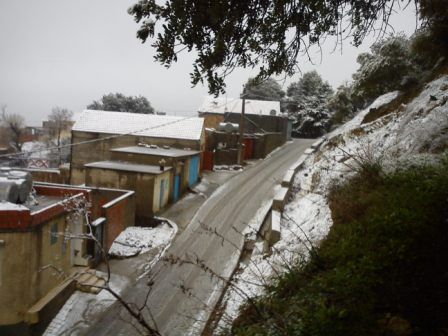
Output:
[198, 96, 281, 115]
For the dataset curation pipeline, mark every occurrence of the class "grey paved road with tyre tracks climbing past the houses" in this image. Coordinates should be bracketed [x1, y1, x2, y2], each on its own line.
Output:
[88, 140, 313, 336]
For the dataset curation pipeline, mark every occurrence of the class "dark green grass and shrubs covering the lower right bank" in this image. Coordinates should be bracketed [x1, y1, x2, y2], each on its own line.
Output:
[228, 159, 448, 336]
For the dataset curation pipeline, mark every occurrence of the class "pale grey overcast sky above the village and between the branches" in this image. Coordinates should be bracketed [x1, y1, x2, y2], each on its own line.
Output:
[0, 0, 415, 126]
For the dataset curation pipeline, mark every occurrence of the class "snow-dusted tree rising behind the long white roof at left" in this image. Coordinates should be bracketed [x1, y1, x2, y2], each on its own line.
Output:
[87, 93, 154, 114]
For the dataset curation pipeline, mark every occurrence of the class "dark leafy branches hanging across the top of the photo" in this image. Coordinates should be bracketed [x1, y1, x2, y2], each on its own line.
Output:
[128, 0, 428, 95]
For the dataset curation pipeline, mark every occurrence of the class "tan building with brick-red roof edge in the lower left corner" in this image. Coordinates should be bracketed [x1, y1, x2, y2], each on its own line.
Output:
[0, 178, 135, 335]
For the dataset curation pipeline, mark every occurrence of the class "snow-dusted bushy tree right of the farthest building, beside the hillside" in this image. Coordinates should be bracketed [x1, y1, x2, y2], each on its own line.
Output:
[285, 71, 333, 138]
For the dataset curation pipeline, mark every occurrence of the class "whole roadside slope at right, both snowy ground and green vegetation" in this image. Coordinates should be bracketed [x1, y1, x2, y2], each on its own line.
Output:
[216, 31, 448, 335]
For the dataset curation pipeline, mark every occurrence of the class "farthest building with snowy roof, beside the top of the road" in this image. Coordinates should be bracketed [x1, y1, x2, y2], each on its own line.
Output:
[198, 96, 292, 169]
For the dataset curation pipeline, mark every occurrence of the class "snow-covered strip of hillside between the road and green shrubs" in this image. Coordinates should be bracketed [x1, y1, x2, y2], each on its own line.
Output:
[218, 76, 448, 332]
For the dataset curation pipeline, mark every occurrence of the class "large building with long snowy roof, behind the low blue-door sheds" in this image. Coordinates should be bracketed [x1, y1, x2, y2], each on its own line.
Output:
[70, 110, 205, 184]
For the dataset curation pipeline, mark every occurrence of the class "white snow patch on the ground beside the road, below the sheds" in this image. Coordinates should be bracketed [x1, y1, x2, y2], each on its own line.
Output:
[109, 223, 176, 258]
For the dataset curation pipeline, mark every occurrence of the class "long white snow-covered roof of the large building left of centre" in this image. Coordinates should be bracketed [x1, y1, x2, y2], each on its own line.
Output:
[72, 110, 204, 140]
